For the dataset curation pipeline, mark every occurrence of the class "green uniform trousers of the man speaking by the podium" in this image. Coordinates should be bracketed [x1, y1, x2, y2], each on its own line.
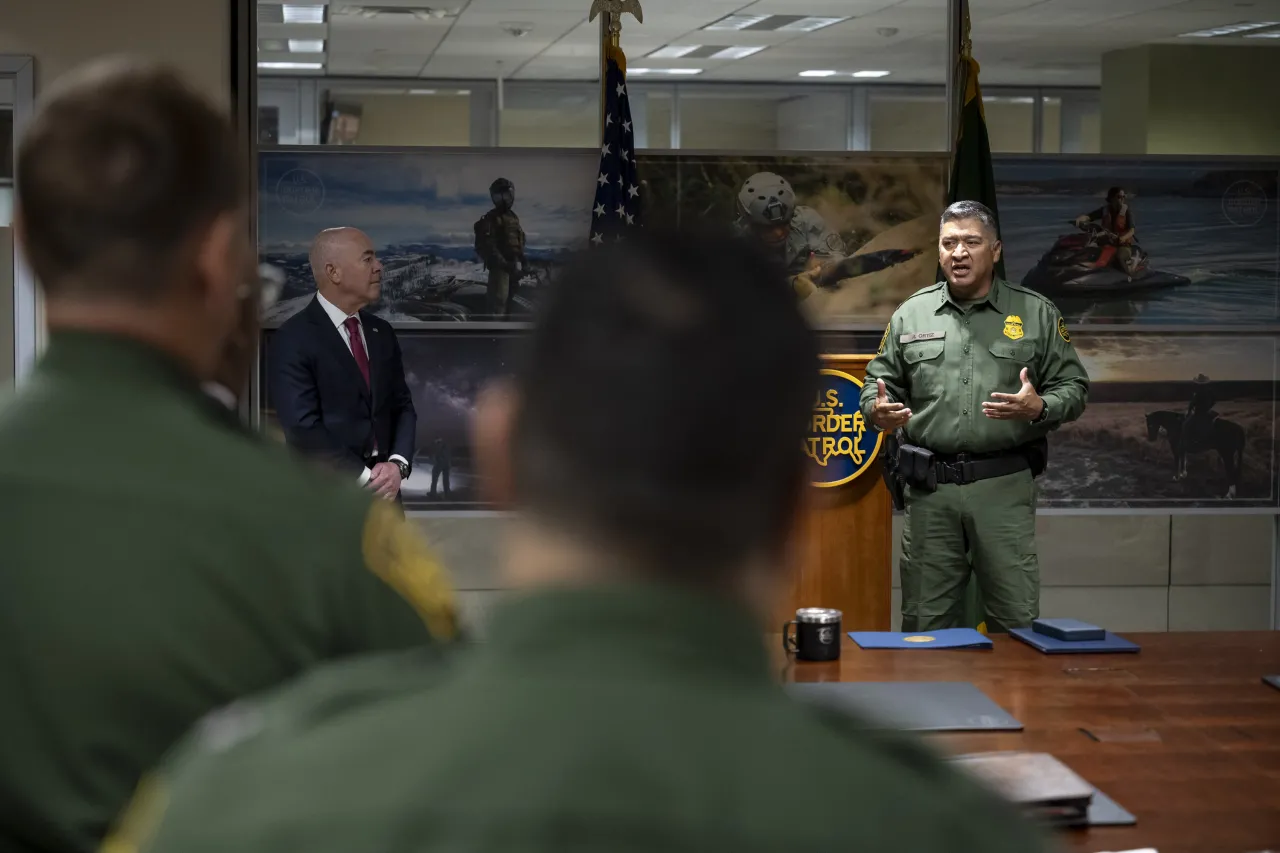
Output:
[899, 471, 1039, 631]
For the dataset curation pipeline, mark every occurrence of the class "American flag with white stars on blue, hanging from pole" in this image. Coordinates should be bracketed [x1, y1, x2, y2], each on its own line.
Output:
[591, 46, 640, 246]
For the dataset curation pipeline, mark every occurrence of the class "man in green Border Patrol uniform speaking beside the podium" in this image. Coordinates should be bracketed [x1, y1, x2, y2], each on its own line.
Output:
[861, 201, 1089, 631]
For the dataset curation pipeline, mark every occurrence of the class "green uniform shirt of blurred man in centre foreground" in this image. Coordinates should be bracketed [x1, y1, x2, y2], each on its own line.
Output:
[115, 587, 1042, 853]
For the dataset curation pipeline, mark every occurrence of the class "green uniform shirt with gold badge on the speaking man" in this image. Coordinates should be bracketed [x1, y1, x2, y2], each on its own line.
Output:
[861, 279, 1089, 453]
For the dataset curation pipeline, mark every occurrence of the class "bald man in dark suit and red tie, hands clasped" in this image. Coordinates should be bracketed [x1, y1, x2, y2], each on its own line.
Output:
[268, 228, 417, 500]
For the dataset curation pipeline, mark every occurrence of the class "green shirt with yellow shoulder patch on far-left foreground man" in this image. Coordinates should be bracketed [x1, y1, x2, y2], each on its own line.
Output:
[0, 333, 452, 853]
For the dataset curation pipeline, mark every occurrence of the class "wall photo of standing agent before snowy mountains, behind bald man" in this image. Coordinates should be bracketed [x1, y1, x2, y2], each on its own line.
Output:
[257, 149, 596, 328]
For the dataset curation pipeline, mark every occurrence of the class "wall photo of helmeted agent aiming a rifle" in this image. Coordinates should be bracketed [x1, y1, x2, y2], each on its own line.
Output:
[637, 152, 948, 327]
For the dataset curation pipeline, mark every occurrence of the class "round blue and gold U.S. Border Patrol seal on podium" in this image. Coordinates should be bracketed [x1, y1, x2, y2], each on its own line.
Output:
[804, 368, 883, 488]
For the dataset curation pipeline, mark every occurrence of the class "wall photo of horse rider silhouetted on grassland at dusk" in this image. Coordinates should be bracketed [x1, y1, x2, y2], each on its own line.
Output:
[1039, 332, 1280, 507]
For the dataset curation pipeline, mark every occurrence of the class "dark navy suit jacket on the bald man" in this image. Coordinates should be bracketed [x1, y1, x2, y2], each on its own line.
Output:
[268, 300, 417, 475]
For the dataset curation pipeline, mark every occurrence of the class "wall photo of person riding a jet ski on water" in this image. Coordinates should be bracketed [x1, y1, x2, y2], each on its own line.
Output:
[993, 156, 1280, 325]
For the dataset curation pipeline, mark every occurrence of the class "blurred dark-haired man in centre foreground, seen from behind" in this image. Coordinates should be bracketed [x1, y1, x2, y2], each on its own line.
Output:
[105, 229, 1042, 853]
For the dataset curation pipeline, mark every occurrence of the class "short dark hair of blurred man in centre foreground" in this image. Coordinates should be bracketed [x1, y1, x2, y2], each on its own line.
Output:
[513, 229, 819, 585]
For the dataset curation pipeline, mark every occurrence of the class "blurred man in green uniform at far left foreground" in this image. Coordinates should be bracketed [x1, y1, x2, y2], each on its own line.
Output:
[0, 61, 456, 853]
